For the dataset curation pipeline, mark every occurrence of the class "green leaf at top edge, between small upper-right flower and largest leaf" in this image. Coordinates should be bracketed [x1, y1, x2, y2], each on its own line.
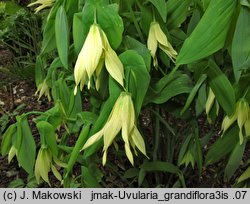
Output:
[167, 0, 191, 30]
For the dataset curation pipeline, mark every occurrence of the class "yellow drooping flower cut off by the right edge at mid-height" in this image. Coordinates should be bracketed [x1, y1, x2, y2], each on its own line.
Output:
[221, 98, 250, 144]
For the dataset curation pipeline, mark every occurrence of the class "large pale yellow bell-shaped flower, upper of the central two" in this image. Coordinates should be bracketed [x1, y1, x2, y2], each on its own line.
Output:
[74, 23, 124, 94]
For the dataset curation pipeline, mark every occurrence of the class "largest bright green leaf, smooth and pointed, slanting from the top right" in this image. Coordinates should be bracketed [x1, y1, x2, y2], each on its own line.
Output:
[176, 0, 237, 66]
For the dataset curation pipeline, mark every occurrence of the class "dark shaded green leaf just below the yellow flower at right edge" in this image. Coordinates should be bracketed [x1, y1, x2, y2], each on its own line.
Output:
[205, 126, 239, 165]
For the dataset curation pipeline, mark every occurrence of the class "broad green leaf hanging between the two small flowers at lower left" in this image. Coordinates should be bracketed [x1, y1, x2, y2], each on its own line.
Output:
[17, 116, 36, 174]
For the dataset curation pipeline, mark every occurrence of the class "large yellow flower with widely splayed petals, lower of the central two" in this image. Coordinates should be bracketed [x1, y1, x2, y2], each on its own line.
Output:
[82, 92, 147, 165]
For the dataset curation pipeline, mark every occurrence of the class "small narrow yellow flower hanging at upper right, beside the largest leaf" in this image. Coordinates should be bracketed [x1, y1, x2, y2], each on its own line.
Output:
[147, 21, 177, 67]
